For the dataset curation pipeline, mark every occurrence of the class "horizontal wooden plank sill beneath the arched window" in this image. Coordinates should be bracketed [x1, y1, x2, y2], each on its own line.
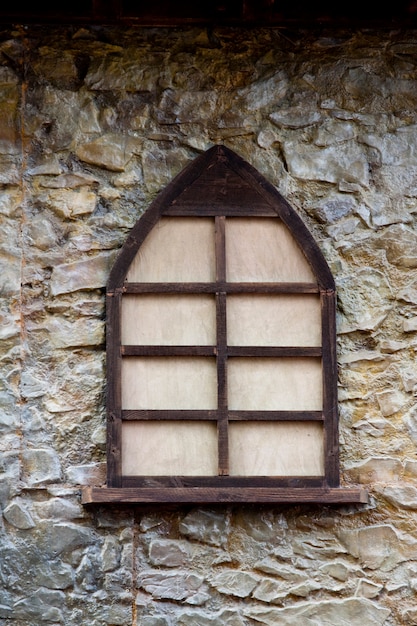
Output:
[81, 487, 368, 505]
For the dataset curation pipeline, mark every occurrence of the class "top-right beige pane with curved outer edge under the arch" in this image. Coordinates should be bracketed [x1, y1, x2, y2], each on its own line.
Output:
[226, 218, 316, 283]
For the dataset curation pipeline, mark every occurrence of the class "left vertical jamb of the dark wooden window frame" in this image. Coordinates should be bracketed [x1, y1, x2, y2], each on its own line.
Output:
[106, 293, 122, 487]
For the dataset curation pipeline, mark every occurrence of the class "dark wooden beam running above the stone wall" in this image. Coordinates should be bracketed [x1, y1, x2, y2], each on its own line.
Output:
[0, 0, 417, 29]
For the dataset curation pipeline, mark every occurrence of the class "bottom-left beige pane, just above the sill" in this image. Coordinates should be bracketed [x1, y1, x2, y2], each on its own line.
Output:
[122, 421, 217, 476]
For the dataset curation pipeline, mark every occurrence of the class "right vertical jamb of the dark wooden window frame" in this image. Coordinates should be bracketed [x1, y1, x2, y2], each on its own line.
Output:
[321, 290, 339, 487]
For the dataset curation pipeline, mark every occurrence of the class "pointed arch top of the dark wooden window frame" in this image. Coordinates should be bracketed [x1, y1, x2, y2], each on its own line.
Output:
[108, 145, 335, 291]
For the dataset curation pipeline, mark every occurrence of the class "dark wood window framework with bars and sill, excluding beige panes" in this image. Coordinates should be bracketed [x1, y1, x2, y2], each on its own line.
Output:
[83, 146, 367, 504]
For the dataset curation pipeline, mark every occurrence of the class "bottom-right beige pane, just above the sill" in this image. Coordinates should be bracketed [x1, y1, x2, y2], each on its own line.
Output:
[229, 422, 324, 476]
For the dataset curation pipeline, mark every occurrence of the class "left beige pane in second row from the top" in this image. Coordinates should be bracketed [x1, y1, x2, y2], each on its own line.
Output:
[122, 295, 216, 346]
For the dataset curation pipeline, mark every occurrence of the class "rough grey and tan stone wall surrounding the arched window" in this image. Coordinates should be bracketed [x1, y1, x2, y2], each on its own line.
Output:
[0, 26, 417, 626]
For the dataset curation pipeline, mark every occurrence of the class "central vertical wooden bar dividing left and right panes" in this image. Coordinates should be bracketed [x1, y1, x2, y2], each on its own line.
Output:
[215, 217, 229, 476]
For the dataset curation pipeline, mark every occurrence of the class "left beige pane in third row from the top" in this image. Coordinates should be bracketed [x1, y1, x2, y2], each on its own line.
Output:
[122, 357, 217, 410]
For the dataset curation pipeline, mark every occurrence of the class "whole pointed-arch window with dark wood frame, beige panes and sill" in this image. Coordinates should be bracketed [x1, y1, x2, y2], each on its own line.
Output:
[83, 146, 366, 503]
